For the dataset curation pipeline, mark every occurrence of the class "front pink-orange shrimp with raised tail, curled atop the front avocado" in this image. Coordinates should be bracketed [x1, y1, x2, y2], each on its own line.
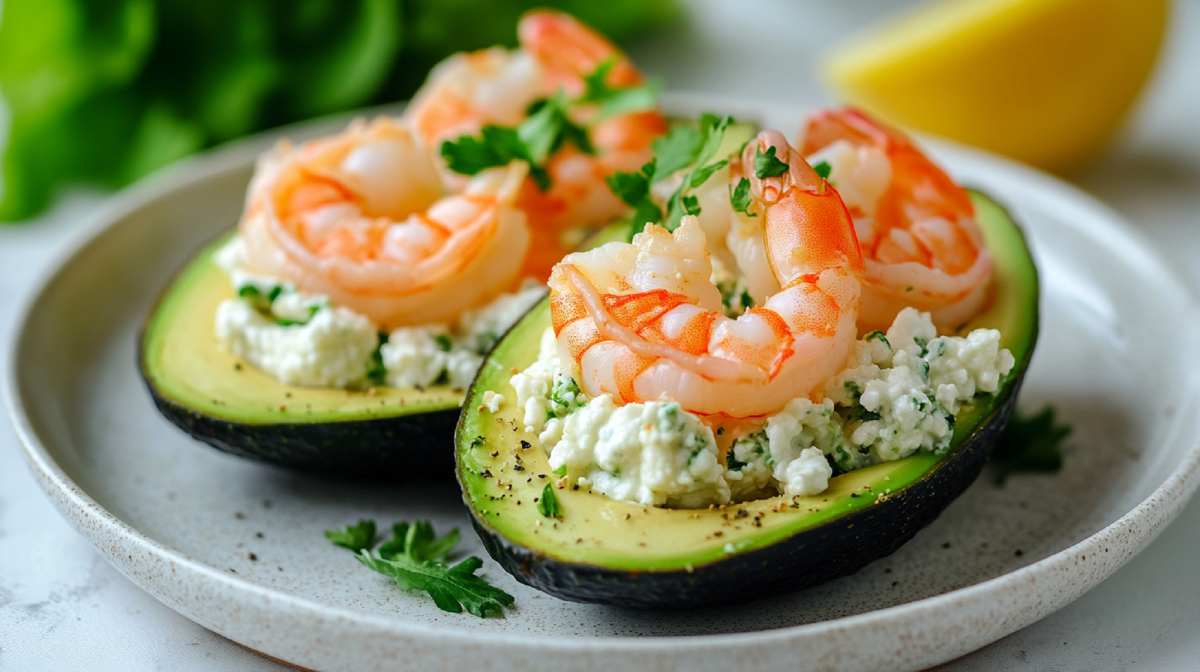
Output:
[550, 131, 863, 421]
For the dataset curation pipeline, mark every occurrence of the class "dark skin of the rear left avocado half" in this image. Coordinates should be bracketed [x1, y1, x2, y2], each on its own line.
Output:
[142, 372, 460, 482]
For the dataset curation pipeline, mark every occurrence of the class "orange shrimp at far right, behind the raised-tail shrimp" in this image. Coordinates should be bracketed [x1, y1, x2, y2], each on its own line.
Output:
[800, 108, 992, 331]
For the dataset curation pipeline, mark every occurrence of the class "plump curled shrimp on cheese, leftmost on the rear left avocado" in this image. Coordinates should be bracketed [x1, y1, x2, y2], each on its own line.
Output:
[240, 118, 530, 330]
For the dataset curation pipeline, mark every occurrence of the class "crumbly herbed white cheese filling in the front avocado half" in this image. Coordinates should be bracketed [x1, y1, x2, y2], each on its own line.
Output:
[511, 308, 1015, 508]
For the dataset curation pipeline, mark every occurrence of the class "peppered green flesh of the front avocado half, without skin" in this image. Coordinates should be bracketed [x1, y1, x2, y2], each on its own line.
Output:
[456, 192, 1038, 578]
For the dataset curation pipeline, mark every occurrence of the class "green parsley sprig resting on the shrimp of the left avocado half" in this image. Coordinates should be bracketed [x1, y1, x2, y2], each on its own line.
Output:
[439, 58, 661, 192]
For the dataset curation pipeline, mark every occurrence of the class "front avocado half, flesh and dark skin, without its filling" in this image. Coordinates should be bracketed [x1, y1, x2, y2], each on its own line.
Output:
[455, 192, 1038, 608]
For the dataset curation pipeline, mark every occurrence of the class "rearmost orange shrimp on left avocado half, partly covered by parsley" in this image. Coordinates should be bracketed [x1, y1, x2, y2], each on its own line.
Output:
[406, 10, 667, 238]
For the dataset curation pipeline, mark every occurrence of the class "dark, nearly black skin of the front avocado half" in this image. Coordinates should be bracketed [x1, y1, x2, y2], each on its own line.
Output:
[468, 379, 1025, 610]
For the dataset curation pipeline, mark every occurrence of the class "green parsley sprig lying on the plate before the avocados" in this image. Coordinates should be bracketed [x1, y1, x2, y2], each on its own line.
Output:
[325, 521, 515, 618]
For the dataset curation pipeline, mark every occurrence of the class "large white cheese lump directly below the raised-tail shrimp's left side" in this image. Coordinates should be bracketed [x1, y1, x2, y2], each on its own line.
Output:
[550, 395, 730, 508]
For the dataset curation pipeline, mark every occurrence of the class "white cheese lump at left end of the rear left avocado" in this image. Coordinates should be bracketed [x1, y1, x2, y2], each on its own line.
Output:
[216, 299, 379, 388]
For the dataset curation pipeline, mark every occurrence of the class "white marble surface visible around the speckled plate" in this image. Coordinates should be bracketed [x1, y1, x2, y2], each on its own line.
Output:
[0, 0, 1200, 672]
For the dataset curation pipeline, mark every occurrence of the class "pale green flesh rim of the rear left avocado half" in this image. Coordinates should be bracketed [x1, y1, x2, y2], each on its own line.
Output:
[143, 238, 463, 425]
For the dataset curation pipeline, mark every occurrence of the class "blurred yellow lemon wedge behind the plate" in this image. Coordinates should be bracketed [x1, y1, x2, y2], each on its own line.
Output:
[826, 0, 1168, 172]
